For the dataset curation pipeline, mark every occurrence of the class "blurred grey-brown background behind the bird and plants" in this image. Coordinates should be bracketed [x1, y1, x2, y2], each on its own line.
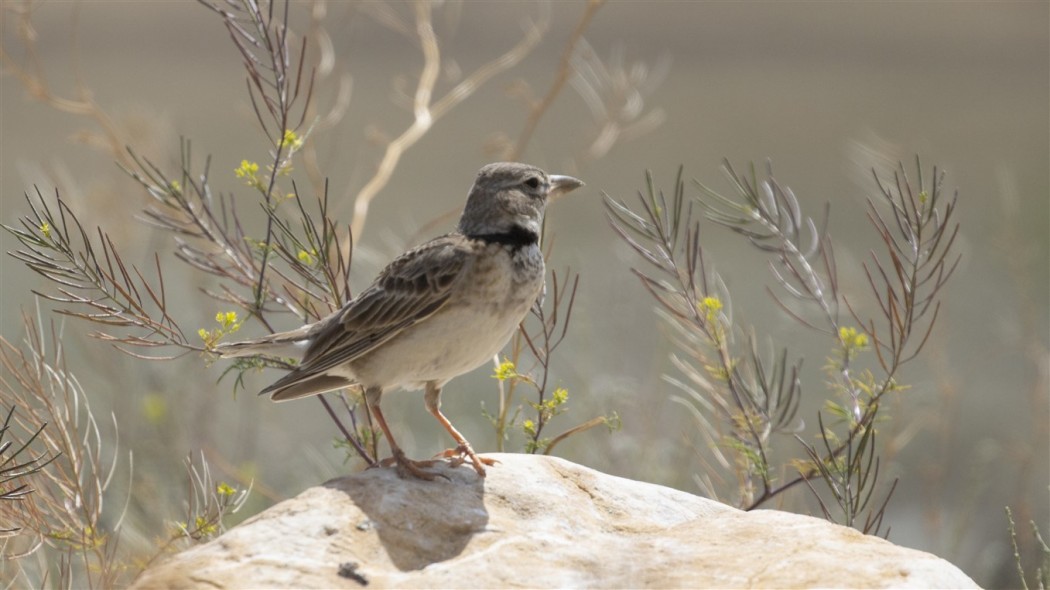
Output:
[0, 0, 1050, 587]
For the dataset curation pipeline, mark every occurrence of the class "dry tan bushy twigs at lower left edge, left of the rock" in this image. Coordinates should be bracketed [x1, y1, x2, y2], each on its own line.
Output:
[0, 316, 131, 587]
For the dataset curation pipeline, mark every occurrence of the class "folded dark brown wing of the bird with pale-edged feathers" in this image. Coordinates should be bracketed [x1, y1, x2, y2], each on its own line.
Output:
[267, 234, 470, 391]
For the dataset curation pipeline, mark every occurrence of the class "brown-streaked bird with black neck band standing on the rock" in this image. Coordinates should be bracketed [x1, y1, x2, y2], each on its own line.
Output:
[215, 162, 584, 480]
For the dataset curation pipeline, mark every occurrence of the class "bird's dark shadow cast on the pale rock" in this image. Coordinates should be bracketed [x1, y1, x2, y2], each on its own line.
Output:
[324, 462, 488, 571]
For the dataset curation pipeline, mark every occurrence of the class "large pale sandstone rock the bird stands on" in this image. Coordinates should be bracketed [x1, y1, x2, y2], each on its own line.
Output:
[133, 455, 977, 588]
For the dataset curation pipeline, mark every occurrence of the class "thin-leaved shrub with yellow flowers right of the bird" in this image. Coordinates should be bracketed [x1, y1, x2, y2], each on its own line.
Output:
[605, 156, 959, 534]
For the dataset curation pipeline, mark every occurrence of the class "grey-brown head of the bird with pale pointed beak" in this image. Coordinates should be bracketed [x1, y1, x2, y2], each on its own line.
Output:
[459, 162, 584, 236]
